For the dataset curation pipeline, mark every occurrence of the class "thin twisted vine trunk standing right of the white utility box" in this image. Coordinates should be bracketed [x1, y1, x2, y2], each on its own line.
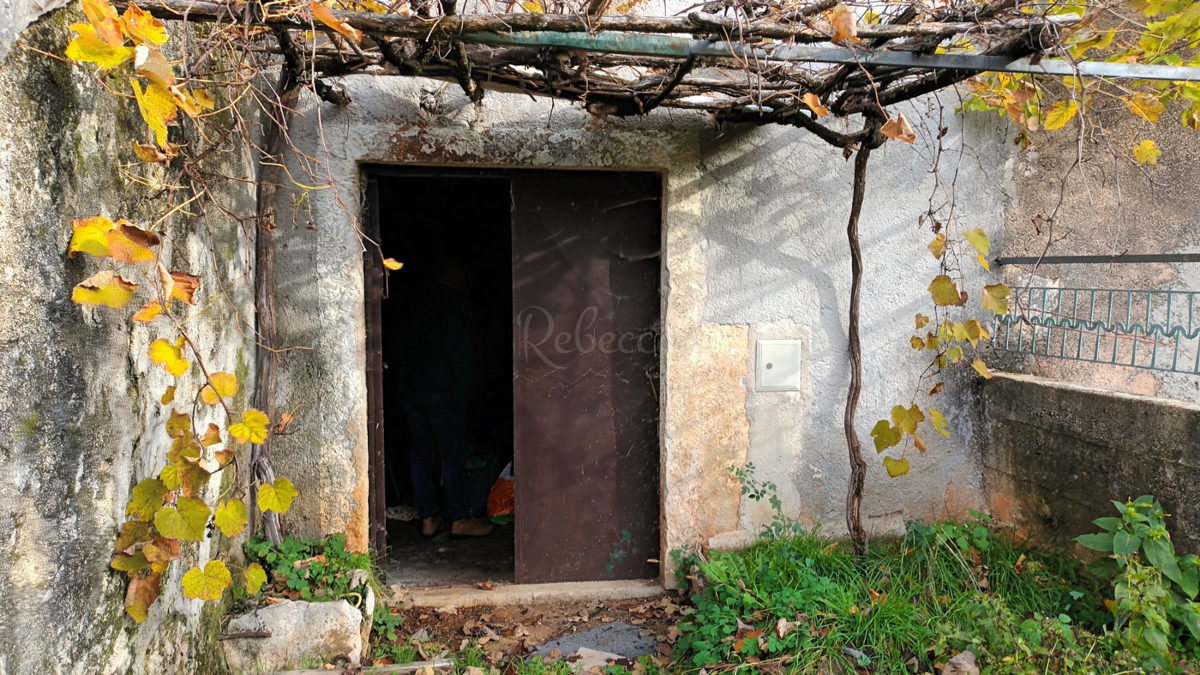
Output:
[842, 135, 877, 556]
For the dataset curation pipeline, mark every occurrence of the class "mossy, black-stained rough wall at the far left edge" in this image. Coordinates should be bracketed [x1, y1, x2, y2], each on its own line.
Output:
[0, 10, 253, 675]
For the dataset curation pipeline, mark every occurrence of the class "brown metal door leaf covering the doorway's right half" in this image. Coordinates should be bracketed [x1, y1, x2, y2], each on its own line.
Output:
[511, 171, 662, 584]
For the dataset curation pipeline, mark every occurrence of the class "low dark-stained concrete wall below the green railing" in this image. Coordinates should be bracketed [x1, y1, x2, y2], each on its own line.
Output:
[982, 375, 1200, 552]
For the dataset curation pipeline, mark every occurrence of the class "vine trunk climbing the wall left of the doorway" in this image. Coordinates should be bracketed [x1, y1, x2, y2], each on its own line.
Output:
[250, 68, 300, 544]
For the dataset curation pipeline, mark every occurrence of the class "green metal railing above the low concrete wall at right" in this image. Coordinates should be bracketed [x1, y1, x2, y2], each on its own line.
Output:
[992, 287, 1200, 375]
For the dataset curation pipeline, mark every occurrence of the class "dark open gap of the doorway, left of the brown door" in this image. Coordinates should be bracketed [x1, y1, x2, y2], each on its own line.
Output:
[364, 173, 514, 586]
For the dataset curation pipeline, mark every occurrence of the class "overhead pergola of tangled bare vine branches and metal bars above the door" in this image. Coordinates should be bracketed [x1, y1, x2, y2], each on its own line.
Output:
[114, 0, 1196, 148]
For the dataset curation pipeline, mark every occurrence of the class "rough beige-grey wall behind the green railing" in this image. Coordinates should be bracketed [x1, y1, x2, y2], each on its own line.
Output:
[995, 106, 1200, 402]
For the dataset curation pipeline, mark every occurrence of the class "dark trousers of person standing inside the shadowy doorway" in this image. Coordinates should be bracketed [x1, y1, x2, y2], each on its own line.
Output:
[404, 393, 470, 520]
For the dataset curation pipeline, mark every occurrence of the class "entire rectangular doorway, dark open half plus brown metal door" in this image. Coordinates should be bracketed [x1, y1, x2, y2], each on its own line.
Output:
[365, 168, 662, 586]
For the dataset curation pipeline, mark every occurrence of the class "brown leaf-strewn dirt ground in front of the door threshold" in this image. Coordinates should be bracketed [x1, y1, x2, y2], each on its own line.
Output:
[379, 593, 686, 665]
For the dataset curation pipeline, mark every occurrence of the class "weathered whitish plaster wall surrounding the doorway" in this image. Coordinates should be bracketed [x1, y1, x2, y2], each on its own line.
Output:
[276, 76, 1010, 571]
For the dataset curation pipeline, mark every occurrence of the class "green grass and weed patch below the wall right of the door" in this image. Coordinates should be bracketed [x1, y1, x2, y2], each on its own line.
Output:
[676, 514, 1140, 674]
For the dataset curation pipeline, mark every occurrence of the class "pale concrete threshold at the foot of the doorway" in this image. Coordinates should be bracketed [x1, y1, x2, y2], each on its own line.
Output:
[403, 579, 667, 609]
